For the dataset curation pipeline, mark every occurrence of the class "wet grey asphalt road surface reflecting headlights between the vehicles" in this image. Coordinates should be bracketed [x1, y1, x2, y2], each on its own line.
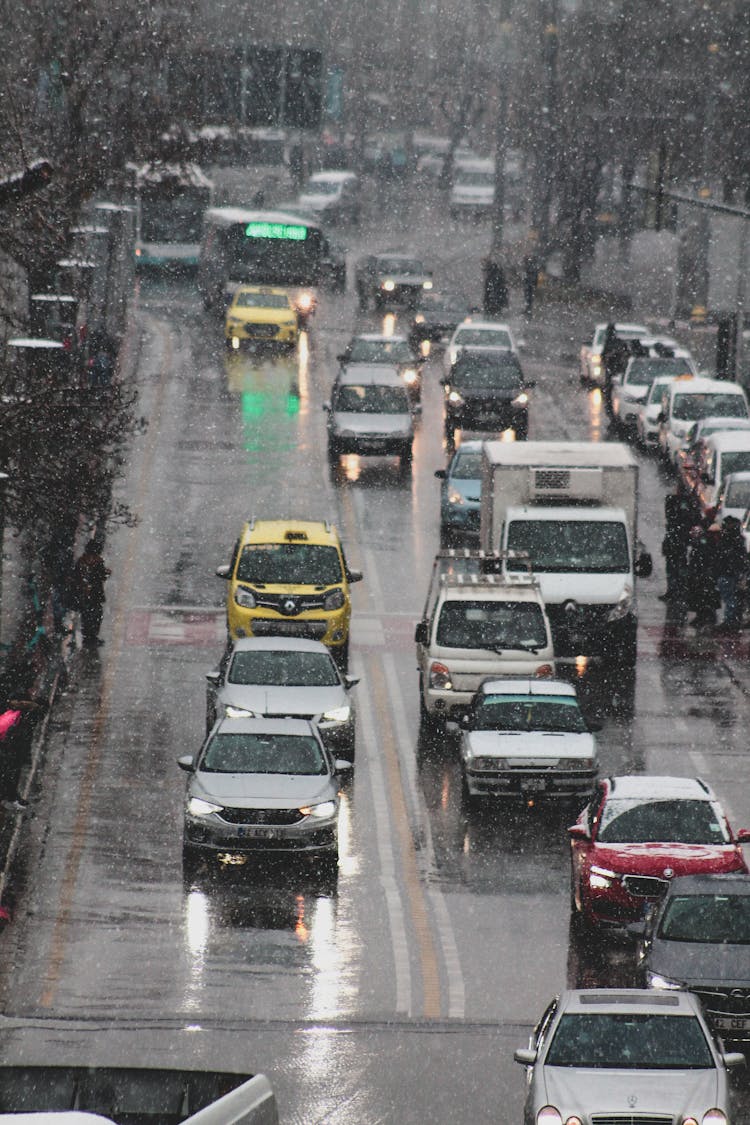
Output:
[0, 180, 750, 1125]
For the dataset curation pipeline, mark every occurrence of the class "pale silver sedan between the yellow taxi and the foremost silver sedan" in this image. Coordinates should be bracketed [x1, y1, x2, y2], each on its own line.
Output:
[206, 637, 359, 762]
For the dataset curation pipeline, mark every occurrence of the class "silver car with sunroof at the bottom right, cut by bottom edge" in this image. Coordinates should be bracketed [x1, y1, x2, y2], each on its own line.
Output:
[515, 989, 744, 1125]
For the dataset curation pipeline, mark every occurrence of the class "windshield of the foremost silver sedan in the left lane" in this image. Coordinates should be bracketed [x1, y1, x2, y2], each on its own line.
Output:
[199, 732, 328, 775]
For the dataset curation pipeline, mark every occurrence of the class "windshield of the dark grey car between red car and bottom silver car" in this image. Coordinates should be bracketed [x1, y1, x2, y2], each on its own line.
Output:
[658, 894, 750, 945]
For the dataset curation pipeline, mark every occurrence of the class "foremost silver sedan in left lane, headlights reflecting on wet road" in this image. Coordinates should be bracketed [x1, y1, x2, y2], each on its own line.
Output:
[178, 719, 351, 872]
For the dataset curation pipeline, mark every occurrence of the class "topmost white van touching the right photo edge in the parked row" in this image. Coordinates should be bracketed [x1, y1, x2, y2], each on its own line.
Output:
[659, 377, 750, 465]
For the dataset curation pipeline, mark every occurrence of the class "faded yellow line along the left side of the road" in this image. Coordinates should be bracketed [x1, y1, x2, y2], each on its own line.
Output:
[39, 326, 172, 1008]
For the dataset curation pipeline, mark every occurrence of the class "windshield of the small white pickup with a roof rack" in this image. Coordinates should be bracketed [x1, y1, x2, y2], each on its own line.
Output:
[436, 600, 548, 651]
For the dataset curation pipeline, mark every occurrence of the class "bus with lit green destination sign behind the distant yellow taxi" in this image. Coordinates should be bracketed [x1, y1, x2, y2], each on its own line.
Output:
[198, 207, 345, 324]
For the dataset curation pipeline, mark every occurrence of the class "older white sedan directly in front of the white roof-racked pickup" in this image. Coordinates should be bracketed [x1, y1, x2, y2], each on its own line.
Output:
[457, 680, 598, 804]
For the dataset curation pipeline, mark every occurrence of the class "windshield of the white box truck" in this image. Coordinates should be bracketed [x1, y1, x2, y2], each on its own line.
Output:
[506, 520, 630, 574]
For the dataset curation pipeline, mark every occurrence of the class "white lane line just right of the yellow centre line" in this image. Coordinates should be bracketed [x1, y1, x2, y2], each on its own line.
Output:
[382, 653, 466, 1019]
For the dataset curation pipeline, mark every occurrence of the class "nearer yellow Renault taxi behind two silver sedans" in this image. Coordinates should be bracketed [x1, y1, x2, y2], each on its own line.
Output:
[216, 520, 362, 668]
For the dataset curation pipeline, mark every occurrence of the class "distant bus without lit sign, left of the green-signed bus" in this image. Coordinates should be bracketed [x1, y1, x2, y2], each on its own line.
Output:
[135, 162, 214, 271]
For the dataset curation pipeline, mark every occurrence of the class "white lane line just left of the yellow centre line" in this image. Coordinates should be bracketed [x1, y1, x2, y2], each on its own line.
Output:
[358, 667, 412, 1016]
